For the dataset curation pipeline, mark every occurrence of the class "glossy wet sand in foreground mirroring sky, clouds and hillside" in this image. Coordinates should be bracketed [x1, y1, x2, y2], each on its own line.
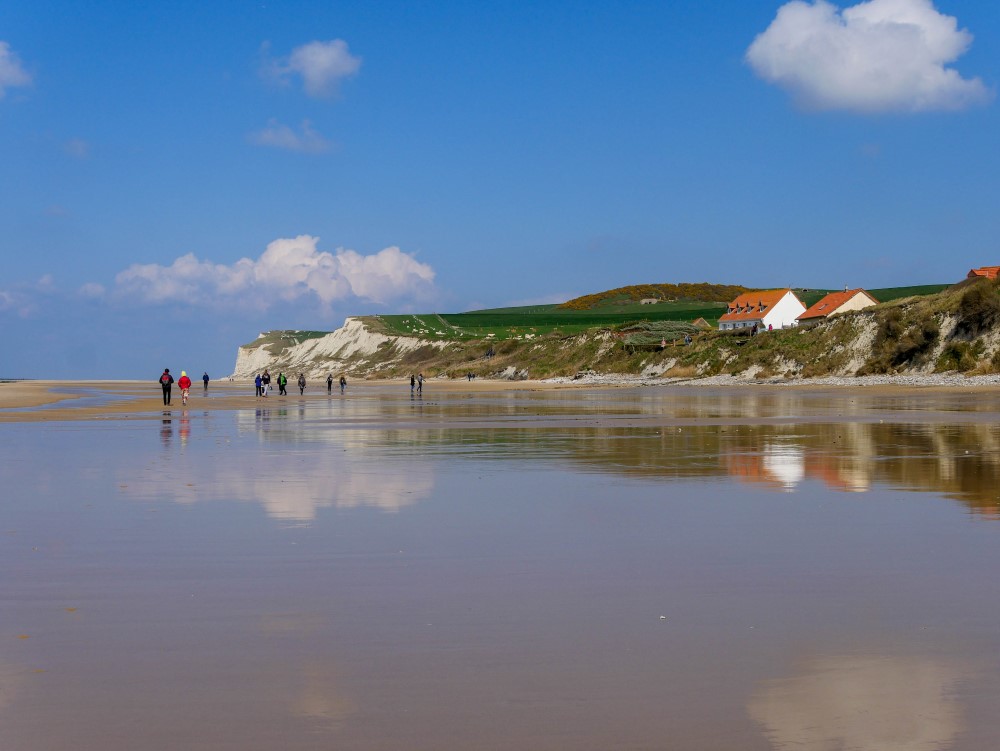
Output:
[0, 390, 1000, 751]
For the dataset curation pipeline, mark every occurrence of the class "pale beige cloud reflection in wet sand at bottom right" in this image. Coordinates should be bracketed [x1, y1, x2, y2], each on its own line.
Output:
[747, 656, 967, 751]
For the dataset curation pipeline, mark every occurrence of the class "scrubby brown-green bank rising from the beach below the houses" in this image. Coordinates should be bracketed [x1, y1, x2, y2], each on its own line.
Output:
[358, 285, 976, 378]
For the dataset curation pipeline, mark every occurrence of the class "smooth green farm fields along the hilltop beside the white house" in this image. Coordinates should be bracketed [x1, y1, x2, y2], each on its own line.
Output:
[376, 284, 949, 340]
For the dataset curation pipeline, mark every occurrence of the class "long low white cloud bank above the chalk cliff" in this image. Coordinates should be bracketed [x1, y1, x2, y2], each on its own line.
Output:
[115, 235, 434, 309]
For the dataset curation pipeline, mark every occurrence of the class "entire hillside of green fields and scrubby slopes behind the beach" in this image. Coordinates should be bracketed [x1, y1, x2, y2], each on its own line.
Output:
[244, 280, 976, 378]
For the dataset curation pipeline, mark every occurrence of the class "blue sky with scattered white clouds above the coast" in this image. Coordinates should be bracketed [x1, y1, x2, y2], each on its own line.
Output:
[0, 0, 1000, 378]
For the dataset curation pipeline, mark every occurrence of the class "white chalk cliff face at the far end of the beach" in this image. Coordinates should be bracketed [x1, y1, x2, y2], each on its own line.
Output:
[232, 318, 444, 379]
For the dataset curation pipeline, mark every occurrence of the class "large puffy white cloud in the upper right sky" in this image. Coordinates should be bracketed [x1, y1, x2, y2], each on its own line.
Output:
[746, 0, 992, 112]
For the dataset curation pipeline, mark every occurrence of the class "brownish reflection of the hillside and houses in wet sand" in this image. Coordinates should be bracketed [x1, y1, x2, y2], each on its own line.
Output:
[383, 422, 1000, 518]
